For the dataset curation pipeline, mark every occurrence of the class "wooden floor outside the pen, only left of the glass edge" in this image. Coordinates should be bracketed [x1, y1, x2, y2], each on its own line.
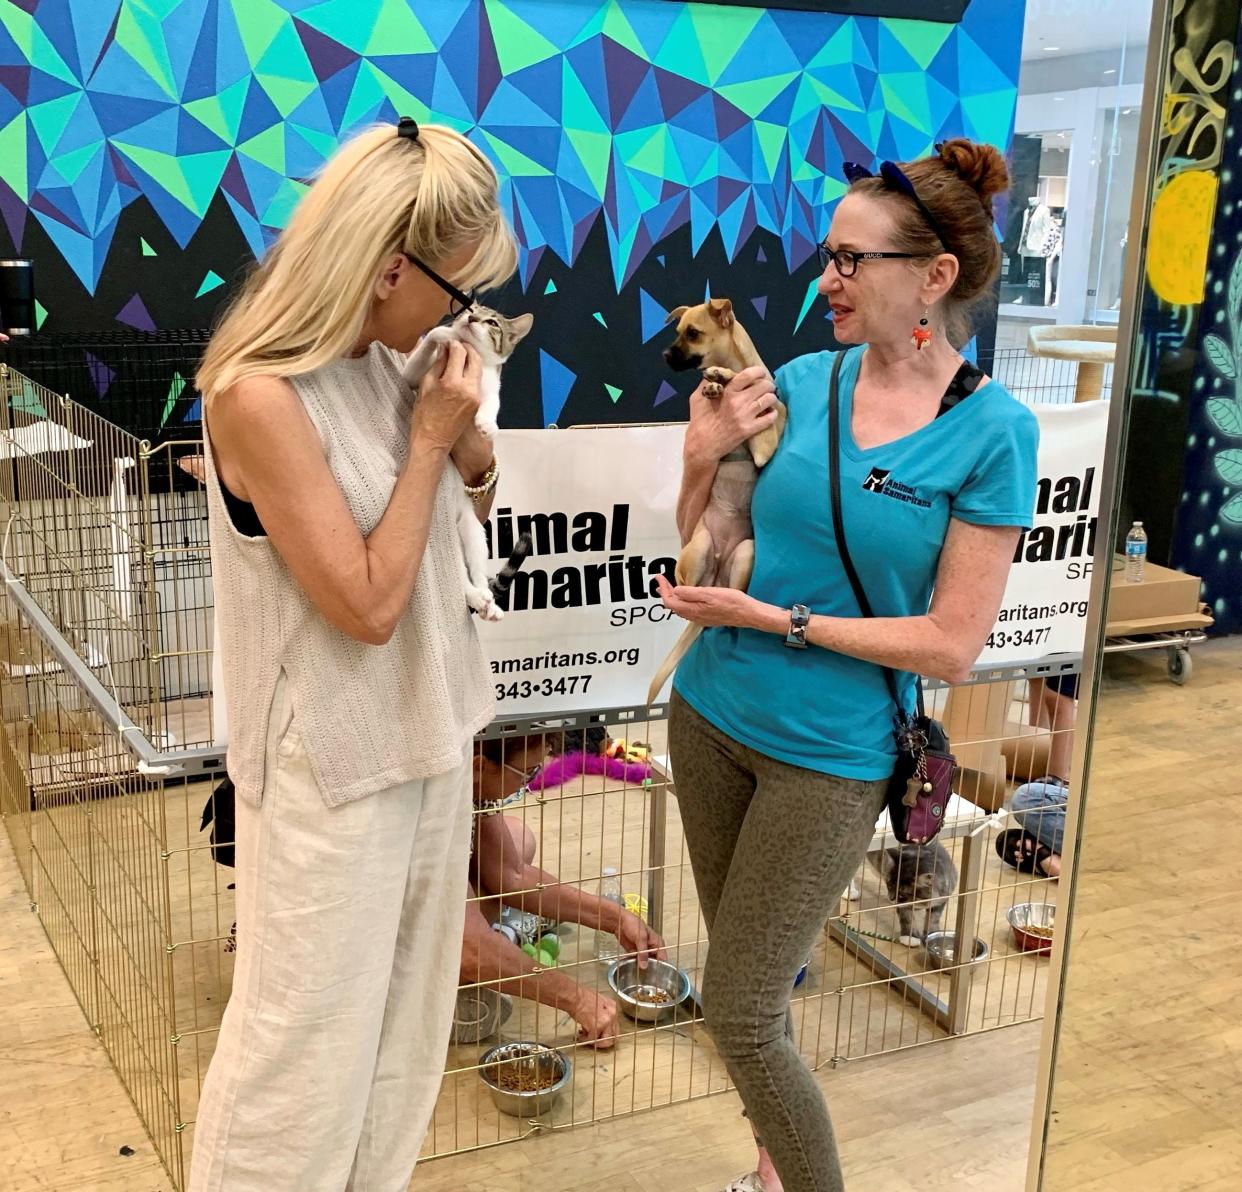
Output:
[0, 833, 1040, 1192]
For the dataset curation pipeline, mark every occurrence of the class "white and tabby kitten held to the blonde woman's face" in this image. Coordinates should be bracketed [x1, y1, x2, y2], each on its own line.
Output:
[401, 304, 534, 621]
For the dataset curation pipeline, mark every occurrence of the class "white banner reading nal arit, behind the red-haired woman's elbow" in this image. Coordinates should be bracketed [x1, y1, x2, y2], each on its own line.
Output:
[979, 401, 1108, 668]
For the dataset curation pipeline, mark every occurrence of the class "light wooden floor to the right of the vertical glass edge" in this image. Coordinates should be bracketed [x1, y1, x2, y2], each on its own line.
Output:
[1045, 637, 1242, 1192]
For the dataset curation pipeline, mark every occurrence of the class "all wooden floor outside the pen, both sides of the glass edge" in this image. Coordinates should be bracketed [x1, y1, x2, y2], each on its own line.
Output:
[0, 642, 1242, 1192]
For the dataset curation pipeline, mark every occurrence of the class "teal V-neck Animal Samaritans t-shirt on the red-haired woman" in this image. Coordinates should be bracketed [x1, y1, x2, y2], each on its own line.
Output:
[673, 350, 1040, 780]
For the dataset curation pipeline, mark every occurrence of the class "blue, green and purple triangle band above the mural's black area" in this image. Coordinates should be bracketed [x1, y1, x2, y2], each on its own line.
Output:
[0, 0, 1023, 298]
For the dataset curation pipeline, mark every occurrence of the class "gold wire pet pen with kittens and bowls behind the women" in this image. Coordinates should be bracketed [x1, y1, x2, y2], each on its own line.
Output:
[0, 370, 1056, 1188]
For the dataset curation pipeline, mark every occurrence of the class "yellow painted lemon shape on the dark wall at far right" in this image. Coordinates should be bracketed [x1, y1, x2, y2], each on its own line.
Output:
[1148, 170, 1217, 307]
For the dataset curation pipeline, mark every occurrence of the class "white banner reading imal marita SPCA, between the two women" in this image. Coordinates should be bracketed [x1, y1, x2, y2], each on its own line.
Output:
[479, 426, 686, 719]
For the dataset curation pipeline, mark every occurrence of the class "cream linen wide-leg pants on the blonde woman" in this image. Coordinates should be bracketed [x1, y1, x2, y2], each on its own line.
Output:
[189, 680, 471, 1192]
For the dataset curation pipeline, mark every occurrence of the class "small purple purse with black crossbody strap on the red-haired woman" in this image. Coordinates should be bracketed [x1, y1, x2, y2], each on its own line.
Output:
[828, 351, 958, 844]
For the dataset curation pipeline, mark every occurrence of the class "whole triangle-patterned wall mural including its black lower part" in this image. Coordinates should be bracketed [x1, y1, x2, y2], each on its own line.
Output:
[0, 0, 1025, 425]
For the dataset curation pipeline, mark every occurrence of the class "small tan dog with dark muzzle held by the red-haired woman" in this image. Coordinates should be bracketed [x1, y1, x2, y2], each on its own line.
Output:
[647, 298, 785, 705]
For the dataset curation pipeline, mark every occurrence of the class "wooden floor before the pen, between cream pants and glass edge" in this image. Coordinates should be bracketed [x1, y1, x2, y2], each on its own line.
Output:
[414, 1023, 1040, 1192]
